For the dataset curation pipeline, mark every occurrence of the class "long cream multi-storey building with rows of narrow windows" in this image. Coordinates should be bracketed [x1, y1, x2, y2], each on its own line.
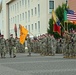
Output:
[0, 0, 66, 38]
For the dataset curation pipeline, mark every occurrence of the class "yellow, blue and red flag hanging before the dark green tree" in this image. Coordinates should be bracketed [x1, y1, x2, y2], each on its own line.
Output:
[52, 10, 61, 35]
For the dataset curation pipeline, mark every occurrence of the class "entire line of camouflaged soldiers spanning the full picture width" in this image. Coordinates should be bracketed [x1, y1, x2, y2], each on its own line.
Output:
[0, 31, 76, 58]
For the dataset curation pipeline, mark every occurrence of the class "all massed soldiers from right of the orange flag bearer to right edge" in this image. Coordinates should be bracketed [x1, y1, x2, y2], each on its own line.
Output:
[25, 31, 76, 58]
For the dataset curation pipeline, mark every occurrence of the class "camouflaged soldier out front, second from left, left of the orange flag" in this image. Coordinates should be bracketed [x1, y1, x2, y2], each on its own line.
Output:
[9, 34, 16, 58]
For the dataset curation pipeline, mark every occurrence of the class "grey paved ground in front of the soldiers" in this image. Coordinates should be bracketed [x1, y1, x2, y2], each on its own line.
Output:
[0, 54, 76, 75]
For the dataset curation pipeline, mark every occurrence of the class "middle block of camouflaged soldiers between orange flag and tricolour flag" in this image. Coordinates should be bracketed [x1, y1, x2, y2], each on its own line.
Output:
[27, 34, 56, 55]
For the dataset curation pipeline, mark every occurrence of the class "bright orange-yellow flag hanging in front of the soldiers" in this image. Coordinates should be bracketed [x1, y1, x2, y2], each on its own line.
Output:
[20, 25, 28, 44]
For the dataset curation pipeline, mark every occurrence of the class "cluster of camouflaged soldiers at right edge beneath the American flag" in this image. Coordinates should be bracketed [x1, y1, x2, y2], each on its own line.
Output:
[64, 32, 76, 58]
